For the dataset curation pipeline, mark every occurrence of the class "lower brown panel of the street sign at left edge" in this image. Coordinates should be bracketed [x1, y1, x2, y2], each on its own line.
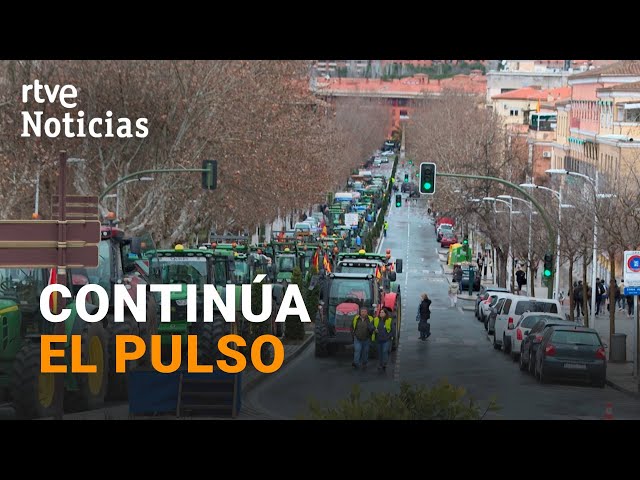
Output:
[0, 245, 98, 268]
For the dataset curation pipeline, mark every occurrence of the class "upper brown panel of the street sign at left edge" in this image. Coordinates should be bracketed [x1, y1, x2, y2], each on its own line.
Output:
[0, 220, 100, 249]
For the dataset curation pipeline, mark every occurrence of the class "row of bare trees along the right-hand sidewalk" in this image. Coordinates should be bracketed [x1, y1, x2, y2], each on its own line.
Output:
[406, 93, 640, 342]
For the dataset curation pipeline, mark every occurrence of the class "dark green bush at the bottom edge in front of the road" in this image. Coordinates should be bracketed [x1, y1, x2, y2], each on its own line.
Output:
[307, 380, 499, 420]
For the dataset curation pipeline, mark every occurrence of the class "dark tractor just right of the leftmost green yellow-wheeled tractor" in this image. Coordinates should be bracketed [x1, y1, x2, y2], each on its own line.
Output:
[72, 213, 159, 400]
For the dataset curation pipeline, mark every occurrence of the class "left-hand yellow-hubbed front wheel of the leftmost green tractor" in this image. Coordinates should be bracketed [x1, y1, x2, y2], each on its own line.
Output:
[9, 343, 62, 419]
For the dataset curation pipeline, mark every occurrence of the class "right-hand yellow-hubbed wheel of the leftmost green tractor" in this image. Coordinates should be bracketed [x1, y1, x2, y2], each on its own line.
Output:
[65, 323, 110, 411]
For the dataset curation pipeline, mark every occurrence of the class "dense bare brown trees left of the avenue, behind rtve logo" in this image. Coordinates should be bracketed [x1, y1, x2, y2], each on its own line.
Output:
[0, 60, 390, 244]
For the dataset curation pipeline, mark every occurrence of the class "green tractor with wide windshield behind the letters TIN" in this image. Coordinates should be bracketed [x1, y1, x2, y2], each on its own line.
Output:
[147, 245, 235, 364]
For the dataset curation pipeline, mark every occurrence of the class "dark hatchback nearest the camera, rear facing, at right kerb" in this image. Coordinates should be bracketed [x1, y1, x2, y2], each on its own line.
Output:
[534, 325, 607, 388]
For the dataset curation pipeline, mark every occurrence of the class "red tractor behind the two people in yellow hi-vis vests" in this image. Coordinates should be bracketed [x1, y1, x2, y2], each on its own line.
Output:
[315, 273, 401, 357]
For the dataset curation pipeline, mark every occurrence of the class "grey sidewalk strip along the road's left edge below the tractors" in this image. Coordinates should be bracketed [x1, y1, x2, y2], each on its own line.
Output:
[63, 330, 314, 420]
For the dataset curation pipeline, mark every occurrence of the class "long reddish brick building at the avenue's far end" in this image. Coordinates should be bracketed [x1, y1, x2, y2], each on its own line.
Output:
[312, 74, 487, 134]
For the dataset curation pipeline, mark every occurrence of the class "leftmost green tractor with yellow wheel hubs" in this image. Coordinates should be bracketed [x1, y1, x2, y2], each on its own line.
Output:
[0, 268, 109, 419]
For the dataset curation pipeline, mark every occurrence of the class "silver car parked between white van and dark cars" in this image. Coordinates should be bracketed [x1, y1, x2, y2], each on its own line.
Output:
[493, 295, 562, 353]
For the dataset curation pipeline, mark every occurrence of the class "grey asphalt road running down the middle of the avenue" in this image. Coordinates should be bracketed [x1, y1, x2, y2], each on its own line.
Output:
[241, 167, 640, 420]
